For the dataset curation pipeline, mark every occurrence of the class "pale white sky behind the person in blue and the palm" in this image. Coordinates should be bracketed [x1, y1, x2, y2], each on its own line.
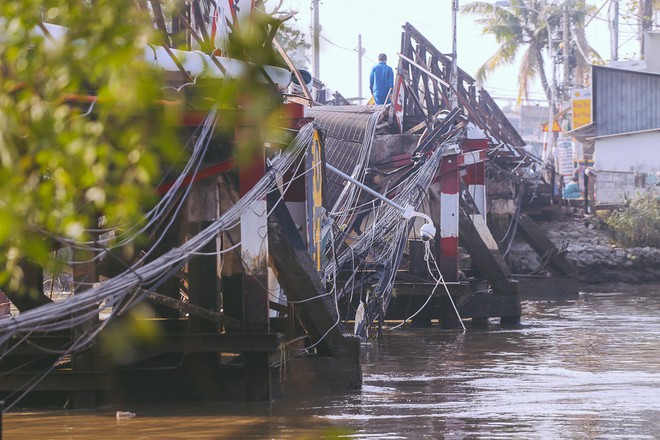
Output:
[276, 0, 639, 103]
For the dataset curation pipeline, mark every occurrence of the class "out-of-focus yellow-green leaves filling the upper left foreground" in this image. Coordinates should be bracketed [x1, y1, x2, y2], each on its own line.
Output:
[0, 0, 179, 290]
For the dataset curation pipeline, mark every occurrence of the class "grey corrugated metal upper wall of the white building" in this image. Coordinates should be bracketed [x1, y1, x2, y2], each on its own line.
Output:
[593, 66, 660, 136]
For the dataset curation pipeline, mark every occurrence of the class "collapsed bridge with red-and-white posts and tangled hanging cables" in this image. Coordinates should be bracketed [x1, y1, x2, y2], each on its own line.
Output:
[0, 17, 571, 406]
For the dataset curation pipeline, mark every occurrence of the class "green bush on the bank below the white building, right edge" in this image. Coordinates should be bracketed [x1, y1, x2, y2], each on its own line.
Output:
[605, 192, 660, 247]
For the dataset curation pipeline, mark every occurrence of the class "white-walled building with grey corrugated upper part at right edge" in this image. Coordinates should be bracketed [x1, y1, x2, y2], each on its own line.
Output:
[569, 34, 660, 205]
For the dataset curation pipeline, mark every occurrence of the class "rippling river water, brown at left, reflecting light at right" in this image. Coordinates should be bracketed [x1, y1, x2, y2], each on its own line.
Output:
[3, 285, 660, 439]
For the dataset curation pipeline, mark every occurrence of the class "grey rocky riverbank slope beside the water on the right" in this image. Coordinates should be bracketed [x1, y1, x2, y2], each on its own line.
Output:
[508, 213, 660, 284]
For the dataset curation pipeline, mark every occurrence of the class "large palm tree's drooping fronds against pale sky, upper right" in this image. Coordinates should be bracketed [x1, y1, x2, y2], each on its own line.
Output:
[461, 0, 600, 101]
